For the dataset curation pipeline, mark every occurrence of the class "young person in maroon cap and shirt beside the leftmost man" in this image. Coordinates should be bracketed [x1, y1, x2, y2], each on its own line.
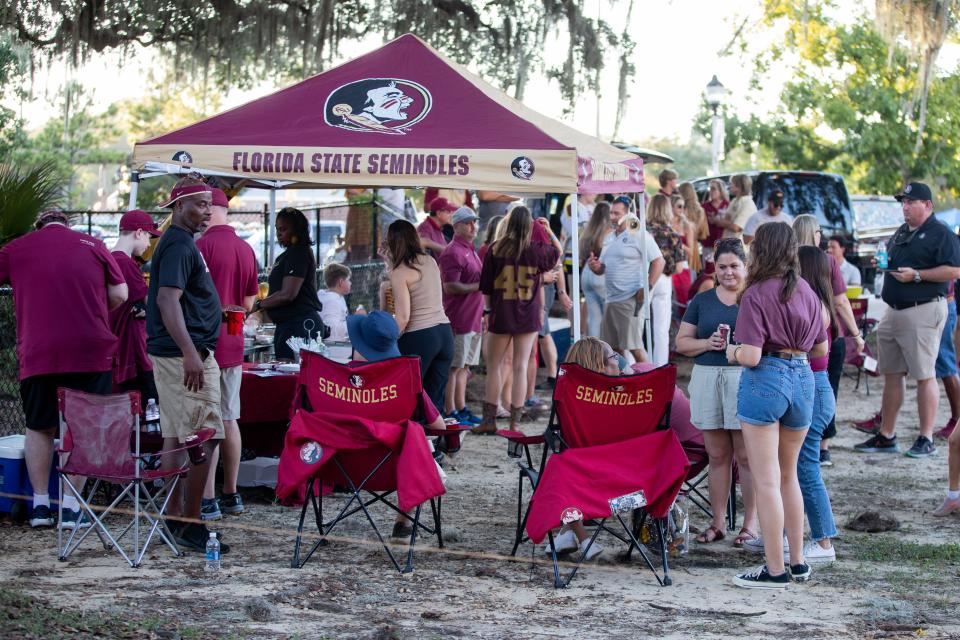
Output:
[109, 209, 160, 406]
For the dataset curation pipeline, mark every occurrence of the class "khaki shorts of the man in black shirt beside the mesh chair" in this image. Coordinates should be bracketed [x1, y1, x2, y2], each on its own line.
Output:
[150, 354, 223, 443]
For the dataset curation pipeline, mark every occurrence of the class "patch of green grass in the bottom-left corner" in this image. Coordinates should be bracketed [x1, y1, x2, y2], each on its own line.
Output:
[0, 587, 218, 639]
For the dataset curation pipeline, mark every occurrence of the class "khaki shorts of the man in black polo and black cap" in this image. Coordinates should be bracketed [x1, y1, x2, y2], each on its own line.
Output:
[877, 299, 947, 380]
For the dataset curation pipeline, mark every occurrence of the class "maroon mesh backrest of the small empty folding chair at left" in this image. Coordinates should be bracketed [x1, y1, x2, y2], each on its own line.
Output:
[58, 389, 140, 477]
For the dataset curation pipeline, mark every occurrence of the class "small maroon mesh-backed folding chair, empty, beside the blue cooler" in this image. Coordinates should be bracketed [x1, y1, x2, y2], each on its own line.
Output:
[57, 388, 214, 567]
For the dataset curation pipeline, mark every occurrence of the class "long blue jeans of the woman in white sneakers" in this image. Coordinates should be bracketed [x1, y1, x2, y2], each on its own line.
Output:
[797, 371, 837, 540]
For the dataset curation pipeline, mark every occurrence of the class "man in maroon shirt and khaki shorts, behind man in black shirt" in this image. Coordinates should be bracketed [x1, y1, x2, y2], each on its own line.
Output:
[197, 189, 257, 520]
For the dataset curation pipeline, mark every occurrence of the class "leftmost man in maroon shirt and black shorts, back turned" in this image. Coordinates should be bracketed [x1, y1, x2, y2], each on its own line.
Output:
[0, 211, 127, 529]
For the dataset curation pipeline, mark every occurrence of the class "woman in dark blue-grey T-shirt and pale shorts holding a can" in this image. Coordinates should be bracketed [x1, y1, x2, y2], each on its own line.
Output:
[677, 238, 759, 547]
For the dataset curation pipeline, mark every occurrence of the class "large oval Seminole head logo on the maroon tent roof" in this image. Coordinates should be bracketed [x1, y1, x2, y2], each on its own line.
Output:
[323, 78, 433, 135]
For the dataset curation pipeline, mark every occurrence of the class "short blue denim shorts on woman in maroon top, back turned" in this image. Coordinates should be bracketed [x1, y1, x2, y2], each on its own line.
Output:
[737, 356, 812, 433]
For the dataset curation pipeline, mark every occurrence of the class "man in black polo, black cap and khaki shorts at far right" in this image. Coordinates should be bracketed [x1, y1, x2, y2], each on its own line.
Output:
[854, 182, 960, 458]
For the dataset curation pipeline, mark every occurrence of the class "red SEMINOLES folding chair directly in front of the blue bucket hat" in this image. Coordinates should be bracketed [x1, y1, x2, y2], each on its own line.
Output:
[277, 351, 444, 573]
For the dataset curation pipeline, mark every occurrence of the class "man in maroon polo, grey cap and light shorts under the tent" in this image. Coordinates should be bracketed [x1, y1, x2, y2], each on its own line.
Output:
[438, 207, 483, 424]
